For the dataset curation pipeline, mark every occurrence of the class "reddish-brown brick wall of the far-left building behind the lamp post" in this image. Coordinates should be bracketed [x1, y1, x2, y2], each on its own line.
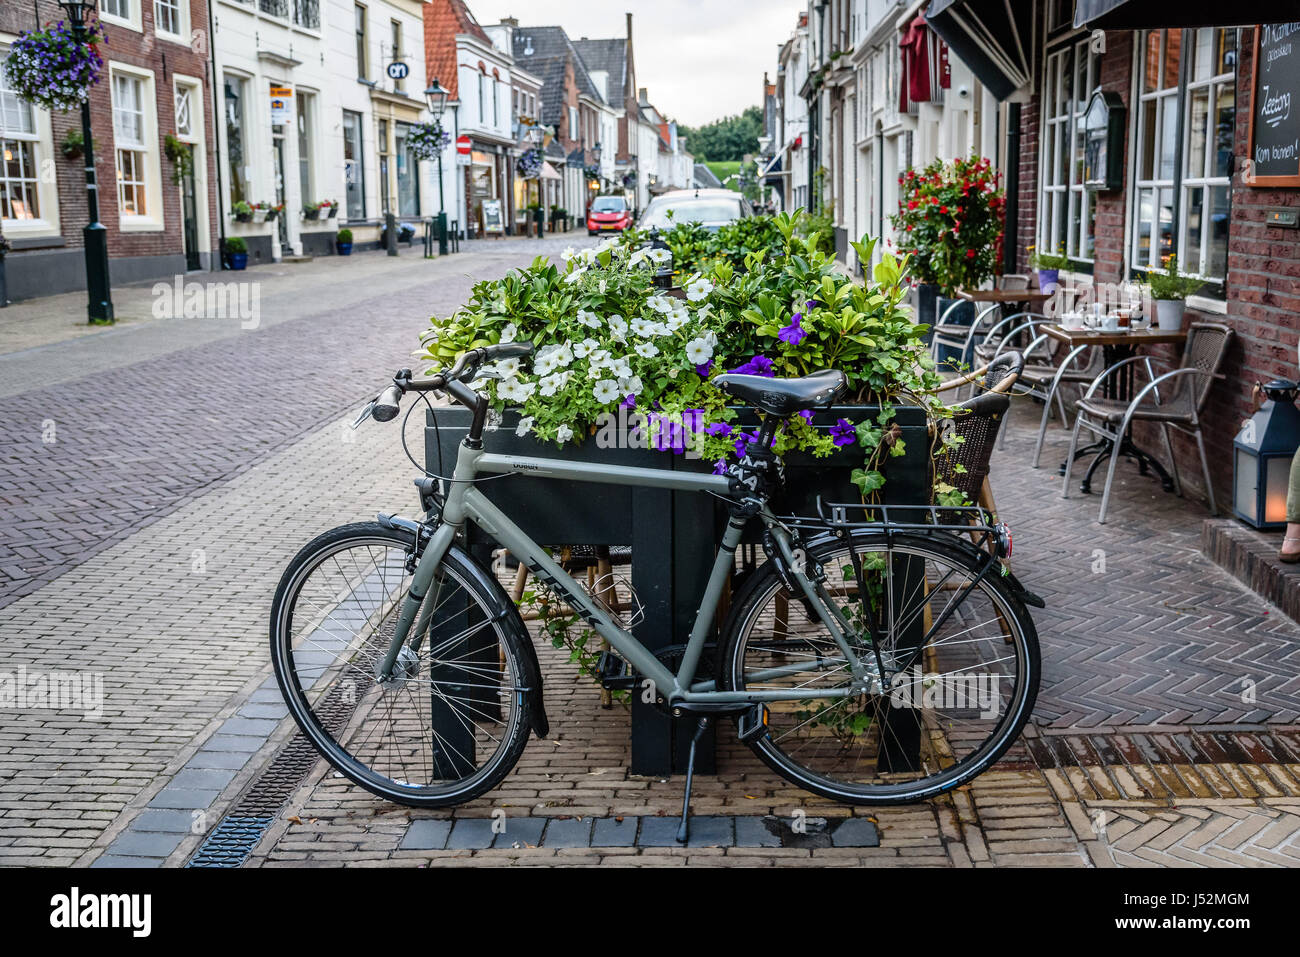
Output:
[0, 0, 218, 298]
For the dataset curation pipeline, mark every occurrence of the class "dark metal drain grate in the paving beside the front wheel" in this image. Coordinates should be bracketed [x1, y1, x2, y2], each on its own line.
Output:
[186, 683, 356, 867]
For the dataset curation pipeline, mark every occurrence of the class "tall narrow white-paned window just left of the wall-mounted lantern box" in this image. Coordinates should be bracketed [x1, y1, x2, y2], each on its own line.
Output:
[1037, 38, 1099, 263]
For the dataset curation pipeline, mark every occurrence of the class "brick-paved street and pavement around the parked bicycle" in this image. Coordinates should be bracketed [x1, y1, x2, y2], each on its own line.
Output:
[0, 237, 1300, 867]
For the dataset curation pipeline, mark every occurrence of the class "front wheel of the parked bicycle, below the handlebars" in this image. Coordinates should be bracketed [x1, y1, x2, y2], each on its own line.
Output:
[270, 523, 538, 807]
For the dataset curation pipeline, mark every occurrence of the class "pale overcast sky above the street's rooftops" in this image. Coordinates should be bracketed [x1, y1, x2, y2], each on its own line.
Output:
[467, 0, 807, 126]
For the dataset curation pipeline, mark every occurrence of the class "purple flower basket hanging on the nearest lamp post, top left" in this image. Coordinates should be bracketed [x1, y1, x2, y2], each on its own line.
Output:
[4, 21, 104, 113]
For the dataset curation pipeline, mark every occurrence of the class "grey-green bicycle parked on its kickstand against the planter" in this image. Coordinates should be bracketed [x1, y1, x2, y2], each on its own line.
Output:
[270, 343, 1041, 841]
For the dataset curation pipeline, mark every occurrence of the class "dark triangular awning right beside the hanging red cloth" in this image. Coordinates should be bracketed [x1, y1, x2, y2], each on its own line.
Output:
[926, 0, 1034, 100]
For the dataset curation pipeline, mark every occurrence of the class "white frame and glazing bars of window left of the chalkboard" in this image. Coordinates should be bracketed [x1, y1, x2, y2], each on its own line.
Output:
[1130, 27, 1240, 291]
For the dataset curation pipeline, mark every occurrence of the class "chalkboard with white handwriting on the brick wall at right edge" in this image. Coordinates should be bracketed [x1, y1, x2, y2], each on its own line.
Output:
[1243, 23, 1300, 186]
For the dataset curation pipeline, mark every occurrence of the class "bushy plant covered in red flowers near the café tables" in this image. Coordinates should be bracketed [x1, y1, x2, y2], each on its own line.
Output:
[889, 156, 1006, 295]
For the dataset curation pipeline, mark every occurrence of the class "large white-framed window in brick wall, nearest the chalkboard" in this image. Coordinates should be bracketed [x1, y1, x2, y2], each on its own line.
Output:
[1132, 27, 1236, 282]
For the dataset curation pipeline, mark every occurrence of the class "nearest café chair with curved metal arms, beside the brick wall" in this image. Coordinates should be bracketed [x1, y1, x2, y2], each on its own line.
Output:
[1061, 322, 1232, 524]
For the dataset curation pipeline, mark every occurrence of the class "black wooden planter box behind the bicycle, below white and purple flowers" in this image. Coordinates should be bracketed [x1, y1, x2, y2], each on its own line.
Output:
[425, 406, 930, 775]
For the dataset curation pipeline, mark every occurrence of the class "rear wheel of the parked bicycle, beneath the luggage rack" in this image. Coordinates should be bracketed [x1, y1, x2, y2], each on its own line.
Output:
[720, 532, 1039, 805]
